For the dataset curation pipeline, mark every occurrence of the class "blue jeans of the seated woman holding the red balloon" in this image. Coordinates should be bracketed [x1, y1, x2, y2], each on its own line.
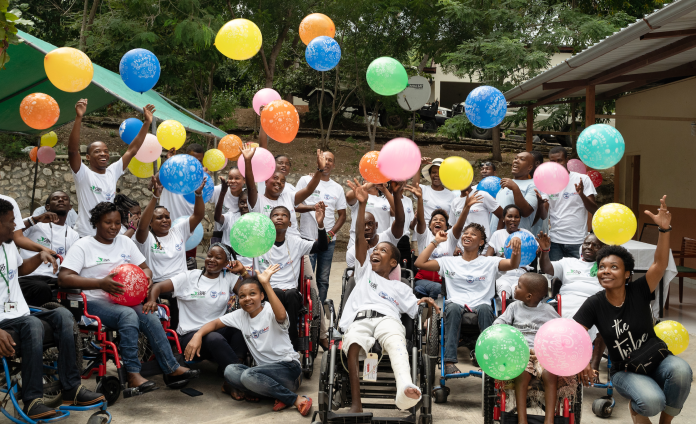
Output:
[87, 300, 179, 374]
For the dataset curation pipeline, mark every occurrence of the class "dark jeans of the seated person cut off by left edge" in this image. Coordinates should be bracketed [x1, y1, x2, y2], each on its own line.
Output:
[0, 308, 81, 405]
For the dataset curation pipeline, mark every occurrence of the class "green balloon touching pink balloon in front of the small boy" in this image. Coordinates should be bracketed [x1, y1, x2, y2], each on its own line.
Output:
[476, 324, 529, 380]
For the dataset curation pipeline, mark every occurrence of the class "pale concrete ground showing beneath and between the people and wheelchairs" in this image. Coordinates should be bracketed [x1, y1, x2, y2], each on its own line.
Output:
[12, 263, 696, 424]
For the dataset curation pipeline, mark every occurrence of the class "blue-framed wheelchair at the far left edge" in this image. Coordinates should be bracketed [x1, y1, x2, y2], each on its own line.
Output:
[0, 307, 111, 424]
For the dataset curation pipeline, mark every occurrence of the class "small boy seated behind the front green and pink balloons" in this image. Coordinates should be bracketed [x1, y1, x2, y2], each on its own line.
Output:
[493, 272, 560, 424]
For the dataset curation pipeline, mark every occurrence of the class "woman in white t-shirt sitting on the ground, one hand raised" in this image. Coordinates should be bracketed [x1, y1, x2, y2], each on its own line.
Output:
[184, 265, 312, 416]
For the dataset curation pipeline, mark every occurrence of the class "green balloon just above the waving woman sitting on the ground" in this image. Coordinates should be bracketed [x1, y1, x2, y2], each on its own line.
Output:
[230, 212, 275, 258]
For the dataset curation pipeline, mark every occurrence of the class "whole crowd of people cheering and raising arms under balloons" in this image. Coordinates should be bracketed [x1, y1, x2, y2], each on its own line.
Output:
[0, 99, 691, 423]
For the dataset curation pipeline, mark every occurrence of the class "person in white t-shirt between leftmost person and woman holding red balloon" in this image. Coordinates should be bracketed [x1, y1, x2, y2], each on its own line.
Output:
[19, 191, 80, 306]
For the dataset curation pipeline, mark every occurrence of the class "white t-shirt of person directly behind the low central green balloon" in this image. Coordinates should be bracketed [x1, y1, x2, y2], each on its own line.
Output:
[254, 233, 314, 290]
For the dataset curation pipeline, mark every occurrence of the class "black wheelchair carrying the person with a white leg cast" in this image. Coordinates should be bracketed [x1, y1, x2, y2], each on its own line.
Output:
[312, 268, 432, 424]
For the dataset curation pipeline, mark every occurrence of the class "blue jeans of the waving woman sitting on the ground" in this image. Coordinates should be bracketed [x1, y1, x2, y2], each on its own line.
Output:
[225, 361, 302, 406]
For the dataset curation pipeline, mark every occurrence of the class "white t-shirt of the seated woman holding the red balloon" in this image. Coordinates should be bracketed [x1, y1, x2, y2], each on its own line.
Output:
[61, 236, 145, 301]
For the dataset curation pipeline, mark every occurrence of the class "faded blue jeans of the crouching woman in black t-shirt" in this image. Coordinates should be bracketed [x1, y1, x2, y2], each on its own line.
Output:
[611, 355, 693, 417]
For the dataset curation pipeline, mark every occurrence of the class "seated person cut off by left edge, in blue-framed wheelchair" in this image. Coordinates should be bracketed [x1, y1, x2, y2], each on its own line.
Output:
[0, 199, 104, 420]
